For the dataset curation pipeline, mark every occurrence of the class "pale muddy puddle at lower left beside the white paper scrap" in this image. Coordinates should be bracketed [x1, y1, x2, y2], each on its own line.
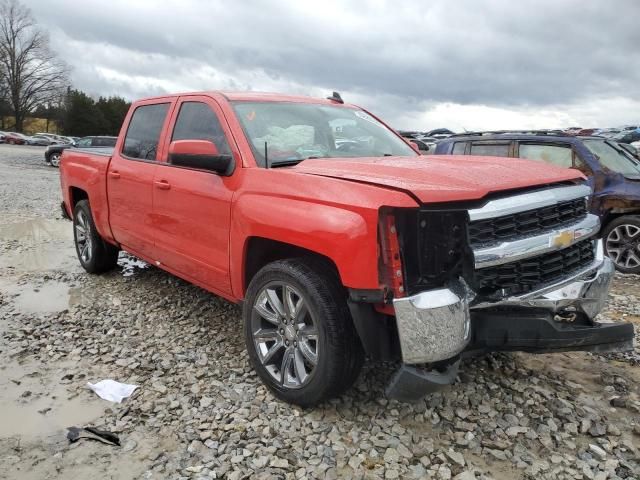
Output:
[0, 362, 107, 440]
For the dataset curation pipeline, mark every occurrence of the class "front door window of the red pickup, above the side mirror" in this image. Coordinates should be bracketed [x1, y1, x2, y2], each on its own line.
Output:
[171, 102, 231, 155]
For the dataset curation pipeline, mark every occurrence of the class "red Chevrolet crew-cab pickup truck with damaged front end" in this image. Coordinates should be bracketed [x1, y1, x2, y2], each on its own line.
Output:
[60, 92, 633, 405]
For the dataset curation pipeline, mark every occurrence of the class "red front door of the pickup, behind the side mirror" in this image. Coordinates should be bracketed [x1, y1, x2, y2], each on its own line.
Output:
[153, 96, 239, 294]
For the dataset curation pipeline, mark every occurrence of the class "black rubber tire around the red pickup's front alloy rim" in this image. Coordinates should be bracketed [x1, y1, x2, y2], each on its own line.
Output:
[243, 258, 364, 407]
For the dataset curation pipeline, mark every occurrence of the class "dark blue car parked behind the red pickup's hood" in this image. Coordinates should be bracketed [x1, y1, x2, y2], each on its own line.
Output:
[434, 131, 640, 274]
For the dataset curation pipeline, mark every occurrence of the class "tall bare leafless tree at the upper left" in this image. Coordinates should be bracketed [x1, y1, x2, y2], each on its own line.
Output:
[0, 0, 68, 131]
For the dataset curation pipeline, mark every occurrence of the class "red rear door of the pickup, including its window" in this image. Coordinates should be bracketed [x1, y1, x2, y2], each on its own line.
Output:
[107, 100, 172, 261]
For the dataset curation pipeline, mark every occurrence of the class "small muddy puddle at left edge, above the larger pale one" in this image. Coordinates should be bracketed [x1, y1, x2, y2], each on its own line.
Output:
[0, 281, 82, 313]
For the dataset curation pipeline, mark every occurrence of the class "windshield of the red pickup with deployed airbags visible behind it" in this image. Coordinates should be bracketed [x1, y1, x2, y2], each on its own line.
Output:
[234, 102, 417, 166]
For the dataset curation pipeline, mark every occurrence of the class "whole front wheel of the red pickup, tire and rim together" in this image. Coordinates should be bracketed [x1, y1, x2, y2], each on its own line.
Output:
[243, 259, 364, 407]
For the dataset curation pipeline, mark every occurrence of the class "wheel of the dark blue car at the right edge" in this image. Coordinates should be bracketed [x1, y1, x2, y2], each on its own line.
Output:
[602, 215, 640, 274]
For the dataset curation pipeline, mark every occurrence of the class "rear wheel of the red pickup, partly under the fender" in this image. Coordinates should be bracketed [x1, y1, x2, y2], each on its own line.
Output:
[73, 200, 119, 273]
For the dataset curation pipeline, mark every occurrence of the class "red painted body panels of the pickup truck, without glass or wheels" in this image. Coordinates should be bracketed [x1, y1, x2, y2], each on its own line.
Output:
[60, 92, 579, 301]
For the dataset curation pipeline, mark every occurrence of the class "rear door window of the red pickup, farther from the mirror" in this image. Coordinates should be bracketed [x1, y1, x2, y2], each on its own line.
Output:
[122, 103, 169, 160]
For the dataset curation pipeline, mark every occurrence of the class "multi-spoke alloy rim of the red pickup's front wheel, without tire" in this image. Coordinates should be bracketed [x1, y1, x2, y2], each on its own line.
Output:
[251, 281, 319, 389]
